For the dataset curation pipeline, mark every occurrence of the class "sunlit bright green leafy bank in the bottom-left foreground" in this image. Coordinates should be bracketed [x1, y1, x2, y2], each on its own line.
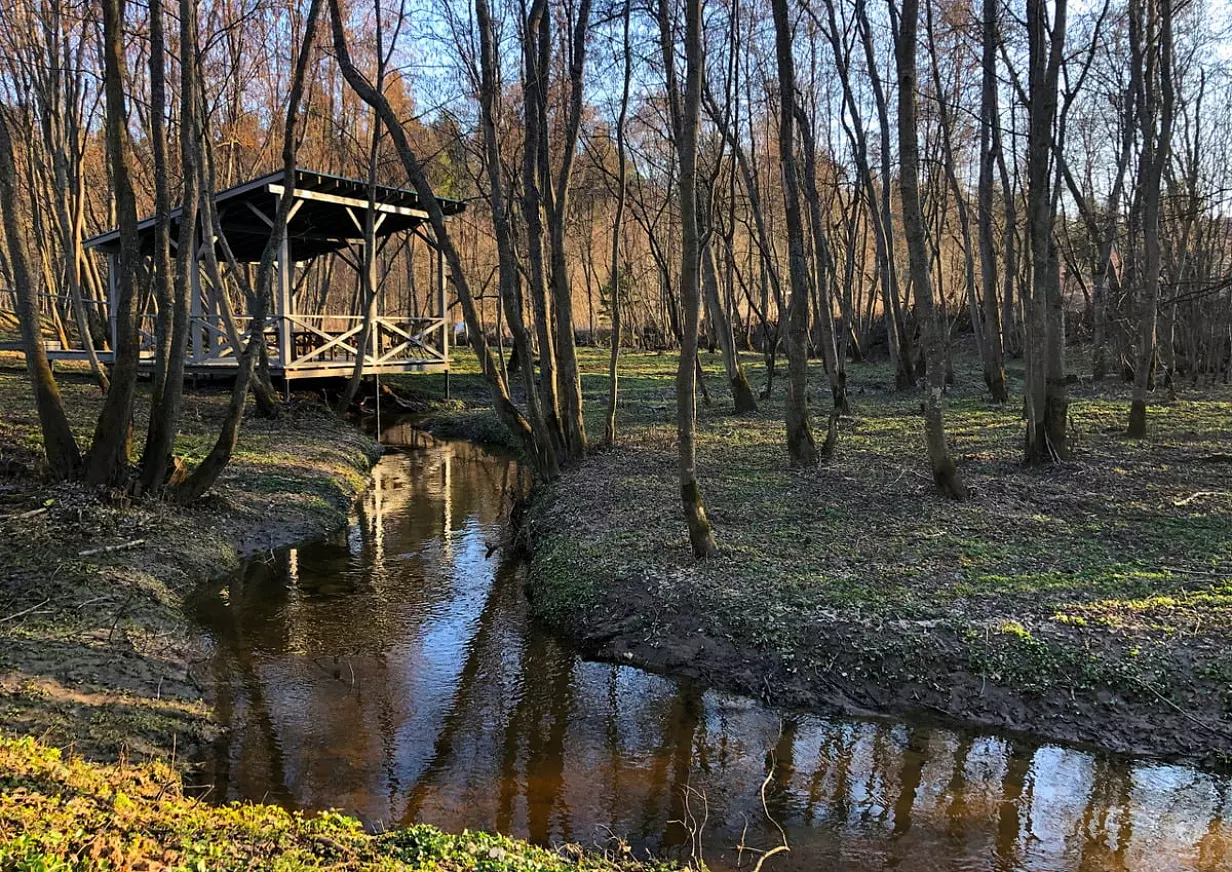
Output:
[0, 737, 658, 872]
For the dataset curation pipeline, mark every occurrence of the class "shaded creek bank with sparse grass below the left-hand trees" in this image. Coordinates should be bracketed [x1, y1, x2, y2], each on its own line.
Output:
[0, 357, 377, 763]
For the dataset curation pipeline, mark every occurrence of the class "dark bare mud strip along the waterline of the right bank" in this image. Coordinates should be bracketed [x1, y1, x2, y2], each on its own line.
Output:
[529, 571, 1232, 771]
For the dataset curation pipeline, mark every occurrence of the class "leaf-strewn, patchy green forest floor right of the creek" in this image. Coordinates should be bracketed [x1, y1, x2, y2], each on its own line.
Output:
[394, 349, 1232, 767]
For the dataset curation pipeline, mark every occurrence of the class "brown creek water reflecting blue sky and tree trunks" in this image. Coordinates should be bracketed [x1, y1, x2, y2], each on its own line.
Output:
[195, 426, 1232, 872]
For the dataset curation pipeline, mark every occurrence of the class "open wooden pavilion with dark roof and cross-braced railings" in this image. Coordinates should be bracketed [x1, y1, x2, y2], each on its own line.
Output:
[74, 169, 466, 384]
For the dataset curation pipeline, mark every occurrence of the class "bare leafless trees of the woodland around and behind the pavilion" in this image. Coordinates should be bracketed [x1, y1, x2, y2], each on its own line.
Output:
[0, 0, 1232, 557]
